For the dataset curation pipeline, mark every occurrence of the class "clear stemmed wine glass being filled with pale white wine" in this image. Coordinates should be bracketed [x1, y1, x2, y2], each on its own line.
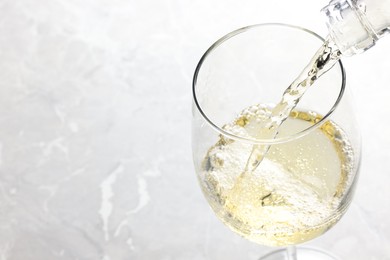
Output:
[192, 24, 360, 260]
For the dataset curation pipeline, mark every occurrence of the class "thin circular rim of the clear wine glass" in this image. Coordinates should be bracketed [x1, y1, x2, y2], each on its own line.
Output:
[192, 23, 346, 144]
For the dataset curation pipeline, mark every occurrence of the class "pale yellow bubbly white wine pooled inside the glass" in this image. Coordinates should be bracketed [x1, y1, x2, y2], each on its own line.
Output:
[199, 105, 354, 246]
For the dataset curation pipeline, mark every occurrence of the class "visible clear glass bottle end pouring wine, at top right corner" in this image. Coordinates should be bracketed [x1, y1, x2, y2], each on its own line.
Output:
[321, 0, 390, 56]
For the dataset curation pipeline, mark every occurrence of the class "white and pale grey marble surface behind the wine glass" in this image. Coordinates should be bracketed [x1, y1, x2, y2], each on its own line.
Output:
[0, 0, 390, 260]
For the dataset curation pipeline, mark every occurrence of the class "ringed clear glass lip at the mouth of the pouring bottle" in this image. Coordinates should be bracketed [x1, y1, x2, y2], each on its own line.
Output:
[321, 0, 379, 56]
